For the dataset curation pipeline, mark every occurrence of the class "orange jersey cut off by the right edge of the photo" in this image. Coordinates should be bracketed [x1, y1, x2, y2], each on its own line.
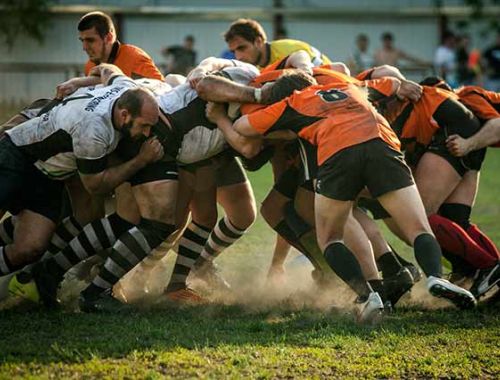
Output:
[457, 86, 500, 121]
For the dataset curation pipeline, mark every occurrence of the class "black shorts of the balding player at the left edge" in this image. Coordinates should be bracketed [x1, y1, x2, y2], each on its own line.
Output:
[0, 136, 64, 223]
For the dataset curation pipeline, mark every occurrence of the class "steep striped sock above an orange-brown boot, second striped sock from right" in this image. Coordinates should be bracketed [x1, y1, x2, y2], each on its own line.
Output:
[166, 221, 210, 293]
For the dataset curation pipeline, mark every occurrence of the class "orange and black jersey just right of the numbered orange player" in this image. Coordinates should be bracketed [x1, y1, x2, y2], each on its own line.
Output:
[384, 86, 458, 146]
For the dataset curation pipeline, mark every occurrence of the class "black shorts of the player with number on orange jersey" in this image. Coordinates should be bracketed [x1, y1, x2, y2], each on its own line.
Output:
[316, 139, 414, 201]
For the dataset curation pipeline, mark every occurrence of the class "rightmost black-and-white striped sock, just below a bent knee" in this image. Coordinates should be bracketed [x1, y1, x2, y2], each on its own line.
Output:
[195, 216, 246, 267]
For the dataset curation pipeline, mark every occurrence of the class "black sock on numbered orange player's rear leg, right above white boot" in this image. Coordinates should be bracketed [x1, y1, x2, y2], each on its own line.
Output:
[413, 233, 443, 277]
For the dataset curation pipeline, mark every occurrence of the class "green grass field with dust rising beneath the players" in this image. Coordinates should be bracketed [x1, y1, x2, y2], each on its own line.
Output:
[0, 108, 500, 379]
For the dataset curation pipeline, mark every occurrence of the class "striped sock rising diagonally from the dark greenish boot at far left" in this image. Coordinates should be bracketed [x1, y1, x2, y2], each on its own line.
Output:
[46, 214, 133, 280]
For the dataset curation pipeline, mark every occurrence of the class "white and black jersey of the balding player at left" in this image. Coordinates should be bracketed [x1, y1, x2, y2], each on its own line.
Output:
[6, 76, 137, 179]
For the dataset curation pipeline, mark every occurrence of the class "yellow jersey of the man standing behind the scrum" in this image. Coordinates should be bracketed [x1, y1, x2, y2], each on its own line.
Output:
[263, 39, 332, 68]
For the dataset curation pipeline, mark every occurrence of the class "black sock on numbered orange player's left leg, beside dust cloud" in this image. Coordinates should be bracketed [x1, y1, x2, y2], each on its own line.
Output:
[325, 242, 371, 297]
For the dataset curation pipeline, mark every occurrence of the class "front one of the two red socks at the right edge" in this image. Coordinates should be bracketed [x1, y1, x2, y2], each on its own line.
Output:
[429, 214, 497, 269]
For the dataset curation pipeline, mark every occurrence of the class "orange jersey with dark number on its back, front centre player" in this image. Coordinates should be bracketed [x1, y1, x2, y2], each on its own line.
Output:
[248, 83, 400, 165]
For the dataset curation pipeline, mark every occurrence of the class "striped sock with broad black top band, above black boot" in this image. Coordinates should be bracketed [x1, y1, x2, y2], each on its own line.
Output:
[82, 219, 175, 298]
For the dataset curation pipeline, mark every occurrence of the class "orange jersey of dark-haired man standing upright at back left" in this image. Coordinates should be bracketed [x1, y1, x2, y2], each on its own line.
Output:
[85, 41, 163, 80]
